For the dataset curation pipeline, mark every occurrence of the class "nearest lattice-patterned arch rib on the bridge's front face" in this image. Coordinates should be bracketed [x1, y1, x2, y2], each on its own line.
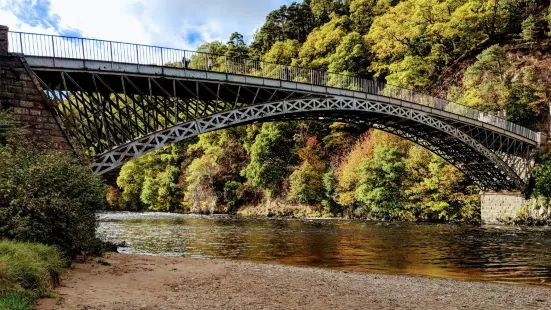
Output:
[93, 97, 526, 189]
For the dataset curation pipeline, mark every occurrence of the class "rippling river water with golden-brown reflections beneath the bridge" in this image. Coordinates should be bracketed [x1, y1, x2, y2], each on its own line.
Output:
[98, 213, 551, 286]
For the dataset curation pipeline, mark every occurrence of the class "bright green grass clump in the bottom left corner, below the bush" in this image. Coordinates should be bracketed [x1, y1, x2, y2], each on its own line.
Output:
[0, 241, 66, 310]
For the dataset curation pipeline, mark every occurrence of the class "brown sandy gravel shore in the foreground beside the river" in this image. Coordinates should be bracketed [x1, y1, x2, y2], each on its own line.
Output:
[38, 253, 551, 310]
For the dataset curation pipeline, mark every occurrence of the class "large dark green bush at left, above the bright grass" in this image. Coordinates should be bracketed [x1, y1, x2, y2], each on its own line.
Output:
[0, 112, 106, 257]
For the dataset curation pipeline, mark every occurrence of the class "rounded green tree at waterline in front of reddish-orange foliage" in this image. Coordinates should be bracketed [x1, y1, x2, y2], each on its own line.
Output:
[356, 147, 405, 218]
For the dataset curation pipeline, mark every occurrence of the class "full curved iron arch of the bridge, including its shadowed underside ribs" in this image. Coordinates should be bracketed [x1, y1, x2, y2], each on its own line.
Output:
[89, 97, 523, 189]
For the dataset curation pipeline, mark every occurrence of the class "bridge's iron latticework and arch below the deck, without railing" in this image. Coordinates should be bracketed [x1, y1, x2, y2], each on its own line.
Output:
[33, 72, 537, 190]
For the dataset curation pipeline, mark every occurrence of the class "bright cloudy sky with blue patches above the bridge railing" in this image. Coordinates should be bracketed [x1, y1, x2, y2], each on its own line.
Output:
[0, 0, 291, 49]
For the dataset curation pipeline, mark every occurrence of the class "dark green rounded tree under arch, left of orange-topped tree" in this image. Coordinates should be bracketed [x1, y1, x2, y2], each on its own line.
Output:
[242, 123, 295, 197]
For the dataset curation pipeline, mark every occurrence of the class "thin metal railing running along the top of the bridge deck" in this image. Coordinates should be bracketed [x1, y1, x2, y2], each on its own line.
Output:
[8, 31, 541, 142]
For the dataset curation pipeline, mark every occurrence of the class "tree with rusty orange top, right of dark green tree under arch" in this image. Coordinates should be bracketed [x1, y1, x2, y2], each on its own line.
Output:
[288, 137, 325, 203]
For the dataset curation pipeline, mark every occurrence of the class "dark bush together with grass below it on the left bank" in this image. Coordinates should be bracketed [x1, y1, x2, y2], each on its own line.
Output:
[0, 111, 106, 310]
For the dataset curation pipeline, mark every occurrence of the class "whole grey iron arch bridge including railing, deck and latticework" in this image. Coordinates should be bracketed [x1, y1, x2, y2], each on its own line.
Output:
[9, 32, 545, 190]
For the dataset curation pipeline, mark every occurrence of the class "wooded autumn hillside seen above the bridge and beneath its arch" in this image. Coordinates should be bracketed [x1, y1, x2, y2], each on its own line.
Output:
[108, 0, 551, 222]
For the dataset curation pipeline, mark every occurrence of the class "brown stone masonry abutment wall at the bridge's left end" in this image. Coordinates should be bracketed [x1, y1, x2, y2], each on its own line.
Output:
[0, 55, 72, 152]
